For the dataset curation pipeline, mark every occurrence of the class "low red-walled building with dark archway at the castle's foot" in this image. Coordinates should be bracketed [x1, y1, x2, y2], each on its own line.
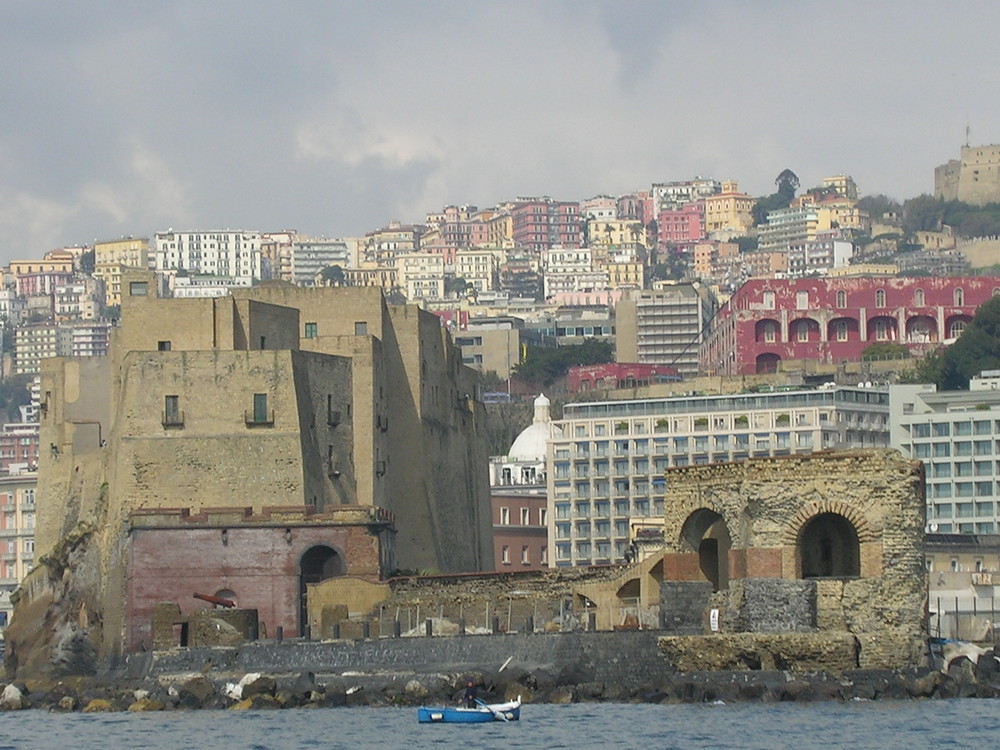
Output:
[126, 506, 395, 651]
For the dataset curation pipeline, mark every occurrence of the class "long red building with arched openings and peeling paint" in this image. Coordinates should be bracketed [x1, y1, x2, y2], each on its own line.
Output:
[701, 276, 1000, 375]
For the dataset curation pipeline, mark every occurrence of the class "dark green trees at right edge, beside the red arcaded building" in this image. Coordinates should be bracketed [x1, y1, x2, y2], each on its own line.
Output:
[915, 297, 1000, 391]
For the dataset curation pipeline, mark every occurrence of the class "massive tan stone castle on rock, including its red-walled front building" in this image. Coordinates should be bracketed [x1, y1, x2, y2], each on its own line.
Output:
[9, 272, 493, 664]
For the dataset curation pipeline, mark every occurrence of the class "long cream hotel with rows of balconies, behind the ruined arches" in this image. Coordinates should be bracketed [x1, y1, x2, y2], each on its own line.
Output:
[546, 387, 889, 566]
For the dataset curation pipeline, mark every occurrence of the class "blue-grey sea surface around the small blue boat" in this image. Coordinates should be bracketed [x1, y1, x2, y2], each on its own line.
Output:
[0, 699, 1000, 750]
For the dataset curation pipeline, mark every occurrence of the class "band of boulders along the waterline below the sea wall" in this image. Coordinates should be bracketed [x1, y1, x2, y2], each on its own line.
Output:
[0, 651, 1000, 713]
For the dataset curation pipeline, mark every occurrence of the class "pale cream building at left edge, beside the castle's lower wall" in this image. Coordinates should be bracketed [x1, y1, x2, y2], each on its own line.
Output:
[0, 472, 38, 627]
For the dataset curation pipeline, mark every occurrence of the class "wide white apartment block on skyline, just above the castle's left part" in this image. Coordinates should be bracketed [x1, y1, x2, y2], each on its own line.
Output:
[154, 229, 261, 279]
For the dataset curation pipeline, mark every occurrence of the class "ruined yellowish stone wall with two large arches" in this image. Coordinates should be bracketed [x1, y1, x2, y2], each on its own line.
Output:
[661, 450, 927, 668]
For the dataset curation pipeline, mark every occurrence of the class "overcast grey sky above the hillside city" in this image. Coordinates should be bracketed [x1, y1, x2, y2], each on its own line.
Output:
[0, 0, 1000, 264]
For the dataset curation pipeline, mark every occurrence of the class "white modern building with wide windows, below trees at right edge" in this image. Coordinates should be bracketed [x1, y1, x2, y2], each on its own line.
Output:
[889, 370, 1000, 534]
